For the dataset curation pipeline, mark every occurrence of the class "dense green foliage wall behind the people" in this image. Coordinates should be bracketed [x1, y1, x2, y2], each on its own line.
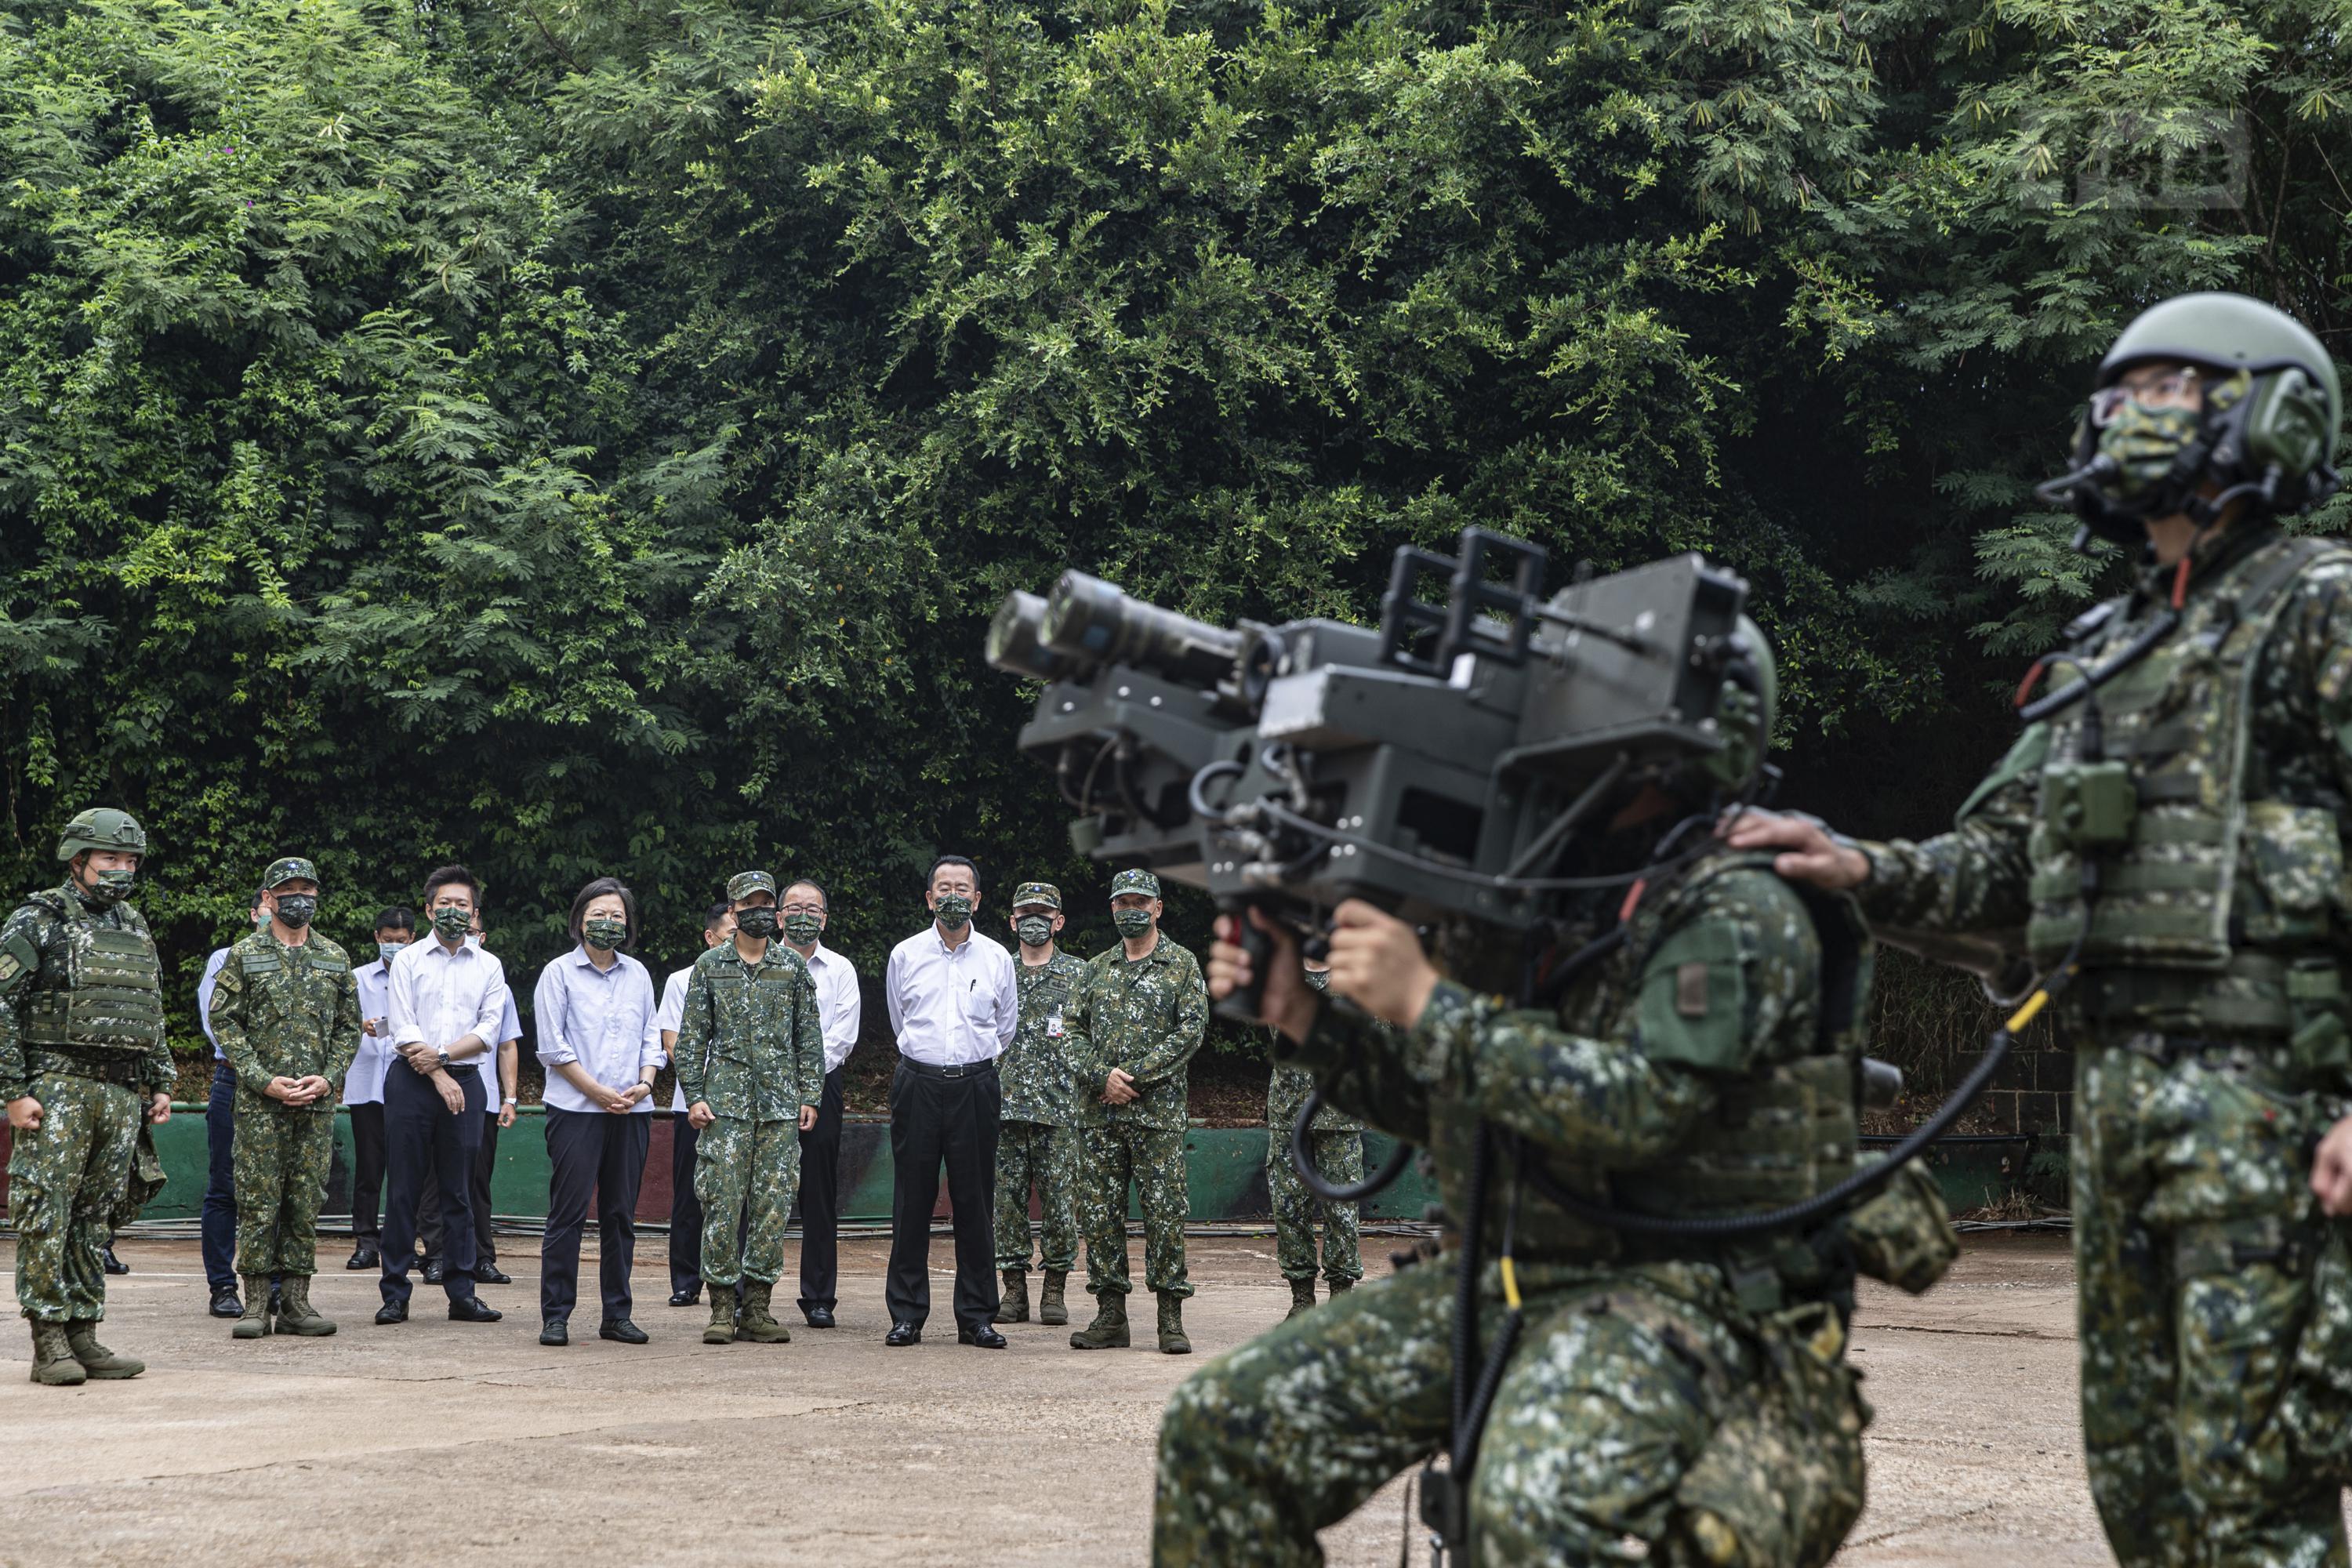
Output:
[0, 0, 2352, 1067]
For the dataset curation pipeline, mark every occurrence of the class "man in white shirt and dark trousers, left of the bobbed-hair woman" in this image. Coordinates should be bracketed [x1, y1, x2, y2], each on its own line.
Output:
[376, 865, 506, 1323]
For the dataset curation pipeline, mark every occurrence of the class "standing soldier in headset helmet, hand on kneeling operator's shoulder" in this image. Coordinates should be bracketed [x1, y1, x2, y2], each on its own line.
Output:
[1733, 294, 2352, 1568]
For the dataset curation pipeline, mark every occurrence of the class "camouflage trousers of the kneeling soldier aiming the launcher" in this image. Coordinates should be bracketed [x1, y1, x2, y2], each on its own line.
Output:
[1152, 1258, 1863, 1568]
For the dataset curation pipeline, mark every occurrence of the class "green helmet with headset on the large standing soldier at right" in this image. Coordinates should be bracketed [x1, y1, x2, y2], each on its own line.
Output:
[2037, 294, 2343, 548]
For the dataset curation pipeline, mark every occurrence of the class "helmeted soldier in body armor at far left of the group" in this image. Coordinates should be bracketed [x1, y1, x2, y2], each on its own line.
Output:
[0, 811, 174, 1387]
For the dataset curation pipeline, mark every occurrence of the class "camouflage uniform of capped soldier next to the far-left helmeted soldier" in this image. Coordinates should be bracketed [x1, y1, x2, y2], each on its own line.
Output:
[209, 928, 360, 1279]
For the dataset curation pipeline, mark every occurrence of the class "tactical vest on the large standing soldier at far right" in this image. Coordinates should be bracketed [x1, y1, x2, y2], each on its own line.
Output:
[2018, 539, 2352, 1046]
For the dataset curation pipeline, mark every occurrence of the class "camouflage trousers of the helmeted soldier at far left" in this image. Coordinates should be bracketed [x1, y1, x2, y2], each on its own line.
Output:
[7, 1072, 146, 1323]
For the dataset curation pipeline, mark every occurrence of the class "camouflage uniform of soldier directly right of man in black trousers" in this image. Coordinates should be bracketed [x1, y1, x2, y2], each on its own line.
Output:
[997, 952, 1087, 1274]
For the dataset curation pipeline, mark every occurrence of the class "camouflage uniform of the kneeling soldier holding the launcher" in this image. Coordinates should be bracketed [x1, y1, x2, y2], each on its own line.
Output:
[1152, 855, 1867, 1568]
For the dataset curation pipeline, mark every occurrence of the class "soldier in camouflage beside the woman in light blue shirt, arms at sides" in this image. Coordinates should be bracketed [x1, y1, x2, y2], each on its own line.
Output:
[677, 872, 826, 1345]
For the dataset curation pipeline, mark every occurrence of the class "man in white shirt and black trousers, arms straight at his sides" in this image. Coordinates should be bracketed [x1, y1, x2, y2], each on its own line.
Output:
[882, 855, 1021, 1349]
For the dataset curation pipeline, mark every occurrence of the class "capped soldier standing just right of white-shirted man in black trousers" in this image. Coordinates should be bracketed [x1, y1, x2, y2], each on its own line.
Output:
[993, 881, 1087, 1323]
